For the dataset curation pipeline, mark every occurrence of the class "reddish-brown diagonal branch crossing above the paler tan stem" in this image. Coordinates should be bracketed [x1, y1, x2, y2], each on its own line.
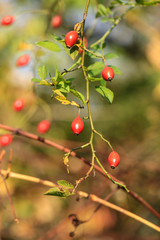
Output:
[0, 124, 160, 218]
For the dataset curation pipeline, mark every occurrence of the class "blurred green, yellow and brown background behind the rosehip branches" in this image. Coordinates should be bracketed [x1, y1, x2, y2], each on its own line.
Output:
[0, 0, 160, 240]
